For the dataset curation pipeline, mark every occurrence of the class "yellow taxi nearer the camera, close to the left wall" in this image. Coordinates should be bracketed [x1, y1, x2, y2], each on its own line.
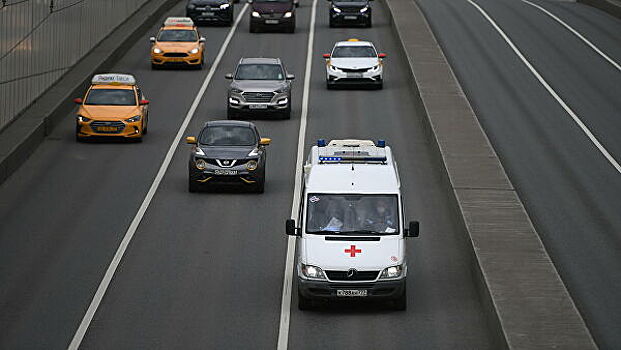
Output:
[73, 73, 149, 141]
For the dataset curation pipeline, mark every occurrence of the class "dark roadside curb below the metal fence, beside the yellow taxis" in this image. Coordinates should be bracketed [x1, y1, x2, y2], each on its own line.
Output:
[0, 0, 179, 184]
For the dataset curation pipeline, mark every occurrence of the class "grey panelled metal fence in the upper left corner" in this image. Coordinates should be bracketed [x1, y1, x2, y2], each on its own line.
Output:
[0, 0, 149, 130]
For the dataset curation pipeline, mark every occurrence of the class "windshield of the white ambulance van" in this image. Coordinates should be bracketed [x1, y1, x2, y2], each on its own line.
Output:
[306, 193, 399, 235]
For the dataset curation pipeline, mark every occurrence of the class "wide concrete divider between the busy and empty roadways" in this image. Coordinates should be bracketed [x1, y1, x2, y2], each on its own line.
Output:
[383, 0, 597, 349]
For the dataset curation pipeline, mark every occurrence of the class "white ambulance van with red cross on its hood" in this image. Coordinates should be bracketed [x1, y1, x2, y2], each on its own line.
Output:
[286, 139, 419, 310]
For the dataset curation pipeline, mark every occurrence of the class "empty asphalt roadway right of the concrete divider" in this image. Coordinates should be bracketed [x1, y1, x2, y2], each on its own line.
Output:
[418, 0, 621, 349]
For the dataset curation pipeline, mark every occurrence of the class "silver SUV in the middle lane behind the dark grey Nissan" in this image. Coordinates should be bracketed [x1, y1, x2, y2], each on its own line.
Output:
[226, 58, 295, 119]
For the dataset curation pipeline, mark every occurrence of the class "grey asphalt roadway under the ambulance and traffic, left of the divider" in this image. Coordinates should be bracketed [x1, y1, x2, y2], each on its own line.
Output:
[0, 1, 492, 349]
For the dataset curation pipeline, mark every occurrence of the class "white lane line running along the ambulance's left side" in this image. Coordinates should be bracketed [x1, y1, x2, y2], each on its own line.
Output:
[277, 0, 317, 350]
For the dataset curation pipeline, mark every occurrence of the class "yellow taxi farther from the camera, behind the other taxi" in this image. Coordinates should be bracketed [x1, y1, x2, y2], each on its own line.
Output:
[150, 17, 205, 69]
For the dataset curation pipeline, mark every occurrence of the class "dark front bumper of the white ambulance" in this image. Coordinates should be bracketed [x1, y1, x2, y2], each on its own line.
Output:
[298, 278, 406, 300]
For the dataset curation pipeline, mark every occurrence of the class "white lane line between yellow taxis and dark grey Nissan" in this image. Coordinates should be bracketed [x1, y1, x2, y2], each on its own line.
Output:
[67, 4, 248, 350]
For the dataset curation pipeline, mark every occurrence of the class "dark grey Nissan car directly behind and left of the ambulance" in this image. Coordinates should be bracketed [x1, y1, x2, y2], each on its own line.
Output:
[186, 120, 271, 193]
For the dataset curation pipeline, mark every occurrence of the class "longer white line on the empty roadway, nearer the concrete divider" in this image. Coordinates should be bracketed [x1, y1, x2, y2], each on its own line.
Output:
[468, 0, 621, 174]
